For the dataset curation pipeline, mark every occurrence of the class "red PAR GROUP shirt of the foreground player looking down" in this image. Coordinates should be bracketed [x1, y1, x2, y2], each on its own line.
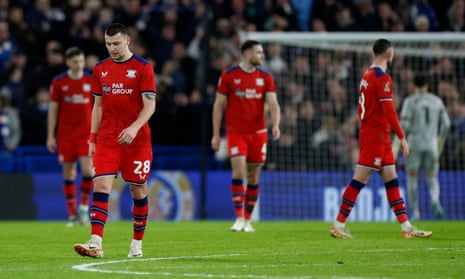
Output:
[92, 55, 156, 150]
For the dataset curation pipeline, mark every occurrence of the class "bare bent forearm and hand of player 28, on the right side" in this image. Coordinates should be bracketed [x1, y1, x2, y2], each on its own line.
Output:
[118, 92, 156, 144]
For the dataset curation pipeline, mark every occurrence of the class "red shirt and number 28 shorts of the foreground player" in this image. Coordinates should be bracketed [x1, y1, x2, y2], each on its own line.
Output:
[92, 55, 156, 184]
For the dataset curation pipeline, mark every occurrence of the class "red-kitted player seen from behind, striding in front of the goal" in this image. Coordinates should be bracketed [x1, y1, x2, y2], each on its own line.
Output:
[330, 39, 432, 238]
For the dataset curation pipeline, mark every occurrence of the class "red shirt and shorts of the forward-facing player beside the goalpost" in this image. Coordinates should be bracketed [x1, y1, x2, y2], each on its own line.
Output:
[217, 66, 276, 163]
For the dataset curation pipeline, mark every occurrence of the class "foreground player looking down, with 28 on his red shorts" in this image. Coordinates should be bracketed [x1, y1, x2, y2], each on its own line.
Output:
[74, 23, 156, 258]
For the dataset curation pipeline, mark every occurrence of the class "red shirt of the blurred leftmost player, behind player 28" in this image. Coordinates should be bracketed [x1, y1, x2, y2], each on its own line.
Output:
[50, 73, 93, 142]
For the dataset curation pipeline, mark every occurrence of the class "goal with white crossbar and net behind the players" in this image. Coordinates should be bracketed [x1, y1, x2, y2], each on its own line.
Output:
[247, 32, 465, 221]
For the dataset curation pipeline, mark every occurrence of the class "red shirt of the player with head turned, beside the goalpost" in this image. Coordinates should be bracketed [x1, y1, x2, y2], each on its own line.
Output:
[217, 65, 276, 133]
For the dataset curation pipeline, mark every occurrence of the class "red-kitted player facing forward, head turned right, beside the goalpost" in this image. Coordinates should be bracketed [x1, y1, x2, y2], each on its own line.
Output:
[211, 40, 281, 232]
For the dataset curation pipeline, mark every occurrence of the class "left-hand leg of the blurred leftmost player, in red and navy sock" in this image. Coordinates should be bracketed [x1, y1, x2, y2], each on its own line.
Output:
[62, 162, 78, 227]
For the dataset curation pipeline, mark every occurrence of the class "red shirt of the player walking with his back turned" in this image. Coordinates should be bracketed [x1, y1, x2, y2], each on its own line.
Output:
[358, 67, 403, 143]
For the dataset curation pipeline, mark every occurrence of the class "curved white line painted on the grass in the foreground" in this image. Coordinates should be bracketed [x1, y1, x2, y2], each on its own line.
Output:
[72, 253, 387, 279]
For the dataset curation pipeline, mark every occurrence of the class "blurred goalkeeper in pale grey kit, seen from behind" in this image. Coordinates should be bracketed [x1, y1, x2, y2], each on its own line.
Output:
[400, 74, 450, 220]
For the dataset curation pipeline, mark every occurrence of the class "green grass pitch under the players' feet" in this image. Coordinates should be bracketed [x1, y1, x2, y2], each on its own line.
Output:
[0, 221, 465, 279]
